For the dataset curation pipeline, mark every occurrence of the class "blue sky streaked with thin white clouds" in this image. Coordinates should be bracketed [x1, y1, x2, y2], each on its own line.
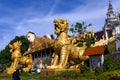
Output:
[0, 0, 120, 50]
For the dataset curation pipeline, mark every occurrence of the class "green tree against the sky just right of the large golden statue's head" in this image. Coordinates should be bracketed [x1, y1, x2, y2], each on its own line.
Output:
[69, 22, 94, 47]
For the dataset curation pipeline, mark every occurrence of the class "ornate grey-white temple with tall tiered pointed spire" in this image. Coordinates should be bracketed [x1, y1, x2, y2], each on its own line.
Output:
[103, 0, 120, 39]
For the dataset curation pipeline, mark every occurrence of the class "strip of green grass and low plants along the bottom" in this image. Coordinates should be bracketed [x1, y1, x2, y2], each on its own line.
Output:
[0, 70, 120, 80]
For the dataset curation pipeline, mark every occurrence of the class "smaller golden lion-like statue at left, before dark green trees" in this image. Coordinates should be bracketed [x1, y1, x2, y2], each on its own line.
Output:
[7, 41, 33, 74]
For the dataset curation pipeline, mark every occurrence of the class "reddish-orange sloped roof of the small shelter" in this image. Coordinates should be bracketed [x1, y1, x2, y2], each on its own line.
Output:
[83, 46, 105, 56]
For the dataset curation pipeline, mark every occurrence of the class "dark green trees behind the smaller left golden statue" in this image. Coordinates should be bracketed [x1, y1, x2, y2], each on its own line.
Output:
[0, 36, 29, 67]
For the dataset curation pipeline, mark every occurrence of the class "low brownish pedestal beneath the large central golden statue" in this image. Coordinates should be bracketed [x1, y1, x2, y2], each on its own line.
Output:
[40, 69, 80, 77]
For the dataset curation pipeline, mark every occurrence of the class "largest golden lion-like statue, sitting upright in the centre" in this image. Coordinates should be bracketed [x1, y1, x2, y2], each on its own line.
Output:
[47, 18, 89, 69]
